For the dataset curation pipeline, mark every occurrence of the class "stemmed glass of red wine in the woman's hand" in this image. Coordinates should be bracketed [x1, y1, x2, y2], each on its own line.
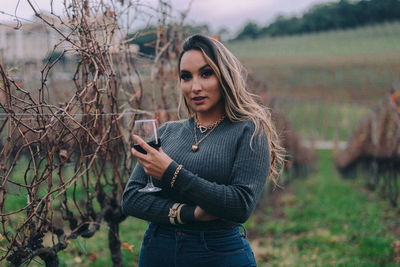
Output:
[133, 120, 161, 193]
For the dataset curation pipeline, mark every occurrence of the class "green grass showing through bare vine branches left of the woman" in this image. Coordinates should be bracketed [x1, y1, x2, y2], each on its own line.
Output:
[0, 157, 147, 267]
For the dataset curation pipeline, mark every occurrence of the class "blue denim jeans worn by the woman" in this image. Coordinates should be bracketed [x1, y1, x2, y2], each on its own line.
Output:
[139, 223, 257, 267]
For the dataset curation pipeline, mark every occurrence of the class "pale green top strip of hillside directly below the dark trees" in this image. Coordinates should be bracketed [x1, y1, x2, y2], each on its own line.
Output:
[229, 22, 400, 58]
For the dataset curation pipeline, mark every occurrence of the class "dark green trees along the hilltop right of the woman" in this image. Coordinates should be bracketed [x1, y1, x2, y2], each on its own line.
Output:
[234, 0, 400, 40]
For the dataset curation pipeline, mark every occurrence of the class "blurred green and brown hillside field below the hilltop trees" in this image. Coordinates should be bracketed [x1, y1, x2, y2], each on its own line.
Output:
[228, 22, 400, 141]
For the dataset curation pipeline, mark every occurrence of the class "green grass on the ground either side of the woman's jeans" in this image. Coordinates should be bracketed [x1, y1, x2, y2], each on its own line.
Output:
[0, 151, 399, 267]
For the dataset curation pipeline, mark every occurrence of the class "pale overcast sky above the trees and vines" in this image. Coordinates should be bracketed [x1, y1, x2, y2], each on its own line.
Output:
[0, 0, 337, 32]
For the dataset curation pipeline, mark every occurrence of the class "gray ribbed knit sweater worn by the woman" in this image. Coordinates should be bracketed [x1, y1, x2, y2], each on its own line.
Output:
[122, 118, 270, 230]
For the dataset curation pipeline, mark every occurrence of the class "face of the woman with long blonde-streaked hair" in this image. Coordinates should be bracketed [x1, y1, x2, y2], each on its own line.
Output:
[179, 50, 224, 118]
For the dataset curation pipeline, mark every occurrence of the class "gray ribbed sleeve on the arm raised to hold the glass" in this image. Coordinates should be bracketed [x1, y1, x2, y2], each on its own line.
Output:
[162, 125, 270, 223]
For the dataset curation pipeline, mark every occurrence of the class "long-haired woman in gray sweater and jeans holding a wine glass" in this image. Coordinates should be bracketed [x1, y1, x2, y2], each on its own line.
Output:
[122, 35, 283, 267]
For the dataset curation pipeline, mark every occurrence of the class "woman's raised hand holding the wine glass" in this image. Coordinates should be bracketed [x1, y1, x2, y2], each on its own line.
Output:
[131, 135, 172, 180]
